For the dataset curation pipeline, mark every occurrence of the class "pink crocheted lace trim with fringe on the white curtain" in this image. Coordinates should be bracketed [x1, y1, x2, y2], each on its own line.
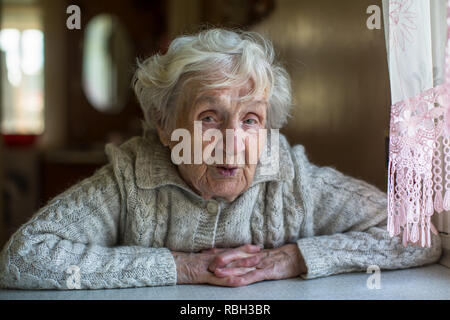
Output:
[387, 0, 450, 247]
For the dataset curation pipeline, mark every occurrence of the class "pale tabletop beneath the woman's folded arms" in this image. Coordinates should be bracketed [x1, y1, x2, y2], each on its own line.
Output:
[0, 264, 450, 300]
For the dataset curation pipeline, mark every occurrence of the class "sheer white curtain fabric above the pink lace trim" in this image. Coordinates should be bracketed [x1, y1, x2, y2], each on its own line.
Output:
[382, 0, 450, 242]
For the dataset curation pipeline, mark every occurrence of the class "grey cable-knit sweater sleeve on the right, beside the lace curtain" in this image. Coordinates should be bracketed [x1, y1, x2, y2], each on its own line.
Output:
[293, 146, 441, 279]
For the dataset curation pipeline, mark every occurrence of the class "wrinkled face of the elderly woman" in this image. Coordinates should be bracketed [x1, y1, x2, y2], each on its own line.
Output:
[159, 82, 268, 201]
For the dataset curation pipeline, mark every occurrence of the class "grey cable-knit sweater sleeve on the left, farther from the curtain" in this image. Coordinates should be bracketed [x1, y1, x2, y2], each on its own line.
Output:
[0, 164, 177, 289]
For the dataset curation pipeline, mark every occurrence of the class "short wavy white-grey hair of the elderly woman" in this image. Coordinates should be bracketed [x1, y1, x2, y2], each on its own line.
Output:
[133, 29, 292, 129]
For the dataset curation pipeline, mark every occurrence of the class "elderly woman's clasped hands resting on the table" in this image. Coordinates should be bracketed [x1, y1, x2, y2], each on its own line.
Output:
[172, 244, 307, 287]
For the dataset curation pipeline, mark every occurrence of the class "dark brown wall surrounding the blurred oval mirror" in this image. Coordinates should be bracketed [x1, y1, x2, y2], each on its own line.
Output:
[65, 0, 166, 148]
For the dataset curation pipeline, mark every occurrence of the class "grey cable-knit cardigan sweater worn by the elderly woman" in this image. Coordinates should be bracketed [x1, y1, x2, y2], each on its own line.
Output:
[0, 133, 441, 289]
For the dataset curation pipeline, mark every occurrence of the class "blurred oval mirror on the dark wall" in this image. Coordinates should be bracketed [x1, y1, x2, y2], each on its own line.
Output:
[82, 14, 133, 113]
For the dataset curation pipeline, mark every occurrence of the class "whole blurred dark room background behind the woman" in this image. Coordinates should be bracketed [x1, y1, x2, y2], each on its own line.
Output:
[0, 0, 390, 246]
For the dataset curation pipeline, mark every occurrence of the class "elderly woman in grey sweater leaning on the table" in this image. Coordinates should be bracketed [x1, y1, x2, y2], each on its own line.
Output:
[0, 29, 441, 289]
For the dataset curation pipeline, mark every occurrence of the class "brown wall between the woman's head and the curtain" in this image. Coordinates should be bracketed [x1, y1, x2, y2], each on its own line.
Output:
[253, 0, 390, 190]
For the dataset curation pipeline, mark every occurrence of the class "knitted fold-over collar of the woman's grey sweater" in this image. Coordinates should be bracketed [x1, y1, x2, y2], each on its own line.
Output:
[135, 130, 294, 195]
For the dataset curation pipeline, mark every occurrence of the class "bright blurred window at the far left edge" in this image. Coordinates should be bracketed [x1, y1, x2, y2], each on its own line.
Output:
[0, 5, 44, 135]
